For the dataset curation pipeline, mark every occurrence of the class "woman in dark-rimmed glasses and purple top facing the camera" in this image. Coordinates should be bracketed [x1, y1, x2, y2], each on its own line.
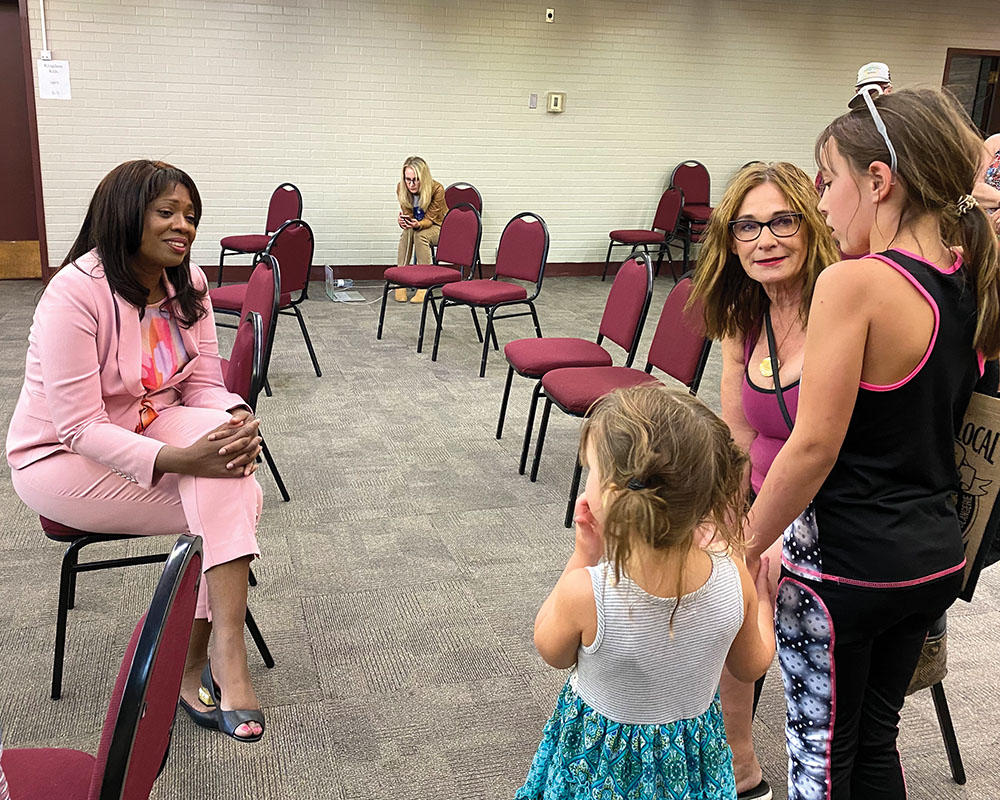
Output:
[692, 161, 838, 800]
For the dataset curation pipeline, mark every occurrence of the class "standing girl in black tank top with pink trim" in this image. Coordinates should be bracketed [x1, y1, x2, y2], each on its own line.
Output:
[747, 84, 1000, 800]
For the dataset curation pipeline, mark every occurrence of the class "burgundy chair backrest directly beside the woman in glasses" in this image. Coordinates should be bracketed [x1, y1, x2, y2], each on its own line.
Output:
[646, 274, 712, 394]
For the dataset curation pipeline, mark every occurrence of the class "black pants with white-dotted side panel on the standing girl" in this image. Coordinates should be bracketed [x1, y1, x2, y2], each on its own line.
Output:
[776, 569, 962, 800]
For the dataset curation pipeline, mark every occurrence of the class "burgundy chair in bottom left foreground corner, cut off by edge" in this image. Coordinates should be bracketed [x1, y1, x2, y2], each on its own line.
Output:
[3, 534, 202, 800]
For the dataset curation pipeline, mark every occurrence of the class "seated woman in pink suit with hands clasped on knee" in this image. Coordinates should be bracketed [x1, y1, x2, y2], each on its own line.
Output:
[7, 161, 264, 741]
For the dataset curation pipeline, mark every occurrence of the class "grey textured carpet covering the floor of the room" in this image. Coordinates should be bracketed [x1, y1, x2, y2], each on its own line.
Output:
[0, 278, 1000, 800]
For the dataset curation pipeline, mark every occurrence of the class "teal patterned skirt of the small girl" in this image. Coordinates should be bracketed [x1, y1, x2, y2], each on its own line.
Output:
[514, 676, 736, 800]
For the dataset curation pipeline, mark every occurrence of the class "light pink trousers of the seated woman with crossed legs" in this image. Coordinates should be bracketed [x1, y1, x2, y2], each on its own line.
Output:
[11, 406, 263, 619]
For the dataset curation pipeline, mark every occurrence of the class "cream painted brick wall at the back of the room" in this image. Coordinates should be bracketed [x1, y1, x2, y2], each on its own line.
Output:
[19, 0, 1000, 264]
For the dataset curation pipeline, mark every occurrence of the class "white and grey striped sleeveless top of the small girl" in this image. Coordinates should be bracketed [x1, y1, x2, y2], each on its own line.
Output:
[576, 553, 743, 725]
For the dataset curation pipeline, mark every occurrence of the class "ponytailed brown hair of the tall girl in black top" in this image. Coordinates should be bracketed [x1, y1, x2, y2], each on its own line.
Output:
[816, 89, 1000, 358]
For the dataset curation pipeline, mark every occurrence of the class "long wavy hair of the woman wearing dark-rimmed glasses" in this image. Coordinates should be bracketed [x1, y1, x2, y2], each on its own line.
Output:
[688, 161, 840, 339]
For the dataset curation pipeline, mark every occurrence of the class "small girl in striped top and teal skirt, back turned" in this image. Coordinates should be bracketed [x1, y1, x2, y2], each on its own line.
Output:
[515, 385, 774, 800]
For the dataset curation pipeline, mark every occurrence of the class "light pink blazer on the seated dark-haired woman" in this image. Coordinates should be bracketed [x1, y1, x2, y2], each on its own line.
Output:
[7, 251, 245, 489]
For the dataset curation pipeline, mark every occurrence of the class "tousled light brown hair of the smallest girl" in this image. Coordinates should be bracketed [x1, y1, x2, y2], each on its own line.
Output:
[580, 385, 748, 597]
